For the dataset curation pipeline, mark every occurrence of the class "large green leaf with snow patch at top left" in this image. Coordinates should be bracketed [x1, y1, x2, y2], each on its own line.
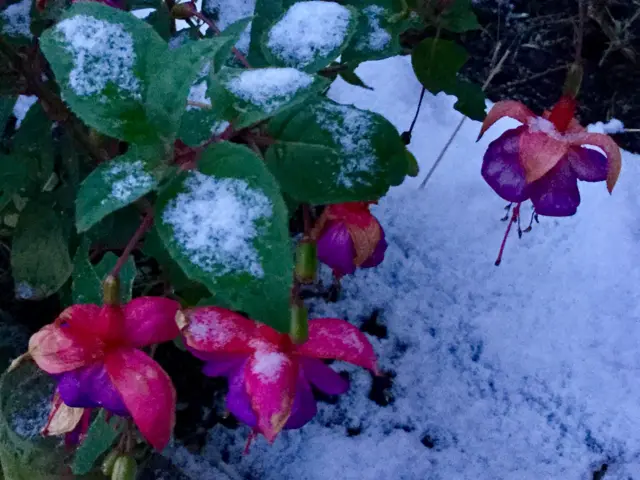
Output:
[40, 2, 167, 141]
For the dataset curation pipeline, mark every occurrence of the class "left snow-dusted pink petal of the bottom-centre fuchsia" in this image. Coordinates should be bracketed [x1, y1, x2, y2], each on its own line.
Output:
[176, 307, 268, 353]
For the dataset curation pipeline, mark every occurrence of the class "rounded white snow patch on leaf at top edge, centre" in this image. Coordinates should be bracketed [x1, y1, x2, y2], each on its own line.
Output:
[267, 1, 351, 68]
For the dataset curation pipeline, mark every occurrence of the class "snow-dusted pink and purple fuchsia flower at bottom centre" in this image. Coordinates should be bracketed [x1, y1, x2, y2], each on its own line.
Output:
[176, 307, 376, 442]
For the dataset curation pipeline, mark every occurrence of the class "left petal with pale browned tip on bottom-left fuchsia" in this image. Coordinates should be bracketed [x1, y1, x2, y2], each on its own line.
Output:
[29, 324, 104, 374]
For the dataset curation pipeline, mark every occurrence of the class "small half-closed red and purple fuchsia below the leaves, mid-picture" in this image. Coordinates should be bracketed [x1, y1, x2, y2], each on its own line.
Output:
[312, 202, 387, 278]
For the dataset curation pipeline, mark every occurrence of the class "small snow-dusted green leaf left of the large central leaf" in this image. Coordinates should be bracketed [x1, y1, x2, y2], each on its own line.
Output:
[76, 145, 167, 232]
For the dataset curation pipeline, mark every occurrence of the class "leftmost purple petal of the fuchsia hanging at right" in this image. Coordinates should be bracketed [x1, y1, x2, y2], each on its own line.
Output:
[482, 126, 529, 202]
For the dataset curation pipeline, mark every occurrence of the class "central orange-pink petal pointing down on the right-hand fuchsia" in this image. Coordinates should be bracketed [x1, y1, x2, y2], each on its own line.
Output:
[520, 130, 569, 183]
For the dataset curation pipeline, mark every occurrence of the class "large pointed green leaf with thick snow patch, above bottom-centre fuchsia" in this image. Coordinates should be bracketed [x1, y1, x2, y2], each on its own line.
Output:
[156, 142, 293, 332]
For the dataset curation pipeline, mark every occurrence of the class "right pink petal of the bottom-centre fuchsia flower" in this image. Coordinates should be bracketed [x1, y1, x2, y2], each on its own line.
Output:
[297, 318, 377, 372]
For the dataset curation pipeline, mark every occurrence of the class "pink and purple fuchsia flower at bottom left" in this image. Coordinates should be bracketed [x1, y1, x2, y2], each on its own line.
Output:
[29, 297, 180, 450]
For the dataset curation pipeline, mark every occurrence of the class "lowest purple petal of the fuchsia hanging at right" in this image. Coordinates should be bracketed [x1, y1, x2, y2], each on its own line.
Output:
[529, 157, 580, 217]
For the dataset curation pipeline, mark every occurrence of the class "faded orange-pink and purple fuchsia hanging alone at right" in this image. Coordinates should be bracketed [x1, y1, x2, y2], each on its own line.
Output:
[478, 96, 621, 217]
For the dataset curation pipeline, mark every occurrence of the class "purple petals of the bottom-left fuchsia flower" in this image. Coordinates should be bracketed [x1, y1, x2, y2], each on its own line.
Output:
[55, 363, 129, 417]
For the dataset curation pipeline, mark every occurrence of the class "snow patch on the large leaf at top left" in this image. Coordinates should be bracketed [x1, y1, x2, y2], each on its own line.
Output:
[55, 15, 140, 101]
